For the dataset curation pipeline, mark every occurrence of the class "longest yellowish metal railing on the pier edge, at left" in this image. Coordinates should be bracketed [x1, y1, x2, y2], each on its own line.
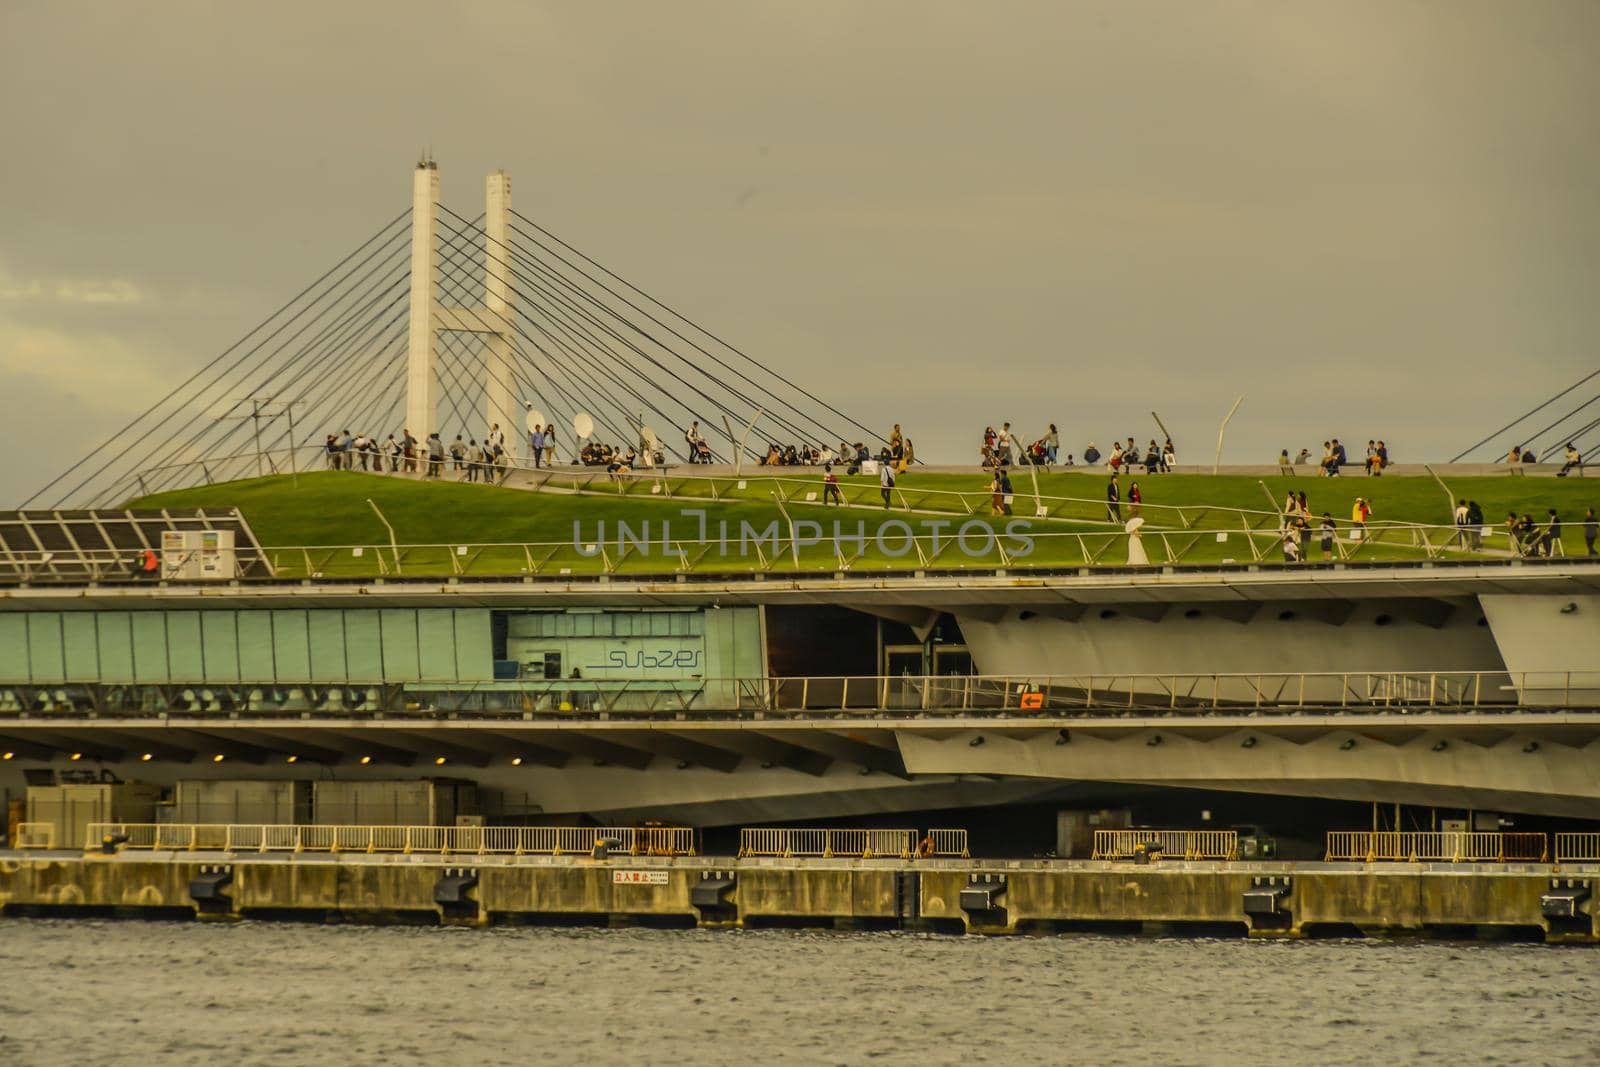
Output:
[85, 822, 694, 856]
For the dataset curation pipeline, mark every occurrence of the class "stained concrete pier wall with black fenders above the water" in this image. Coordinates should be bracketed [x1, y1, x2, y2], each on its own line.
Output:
[0, 851, 1600, 944]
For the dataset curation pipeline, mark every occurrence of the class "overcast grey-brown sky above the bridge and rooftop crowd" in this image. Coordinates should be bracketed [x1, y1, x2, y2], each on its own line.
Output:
[0, 0, 1600, 504]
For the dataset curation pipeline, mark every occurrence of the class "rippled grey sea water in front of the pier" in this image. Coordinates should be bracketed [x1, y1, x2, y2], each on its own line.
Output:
[0, 920, 1600, 1067]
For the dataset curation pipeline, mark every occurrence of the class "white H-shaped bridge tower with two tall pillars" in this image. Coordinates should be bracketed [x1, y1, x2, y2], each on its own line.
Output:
[405, 160, 525, 456]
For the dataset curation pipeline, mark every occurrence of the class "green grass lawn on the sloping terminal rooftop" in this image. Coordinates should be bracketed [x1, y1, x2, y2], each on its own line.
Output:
[130, 470, 1600, 577]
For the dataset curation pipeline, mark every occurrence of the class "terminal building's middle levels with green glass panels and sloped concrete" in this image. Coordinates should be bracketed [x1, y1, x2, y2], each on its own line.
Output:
[0, 560, 1600, 829]
